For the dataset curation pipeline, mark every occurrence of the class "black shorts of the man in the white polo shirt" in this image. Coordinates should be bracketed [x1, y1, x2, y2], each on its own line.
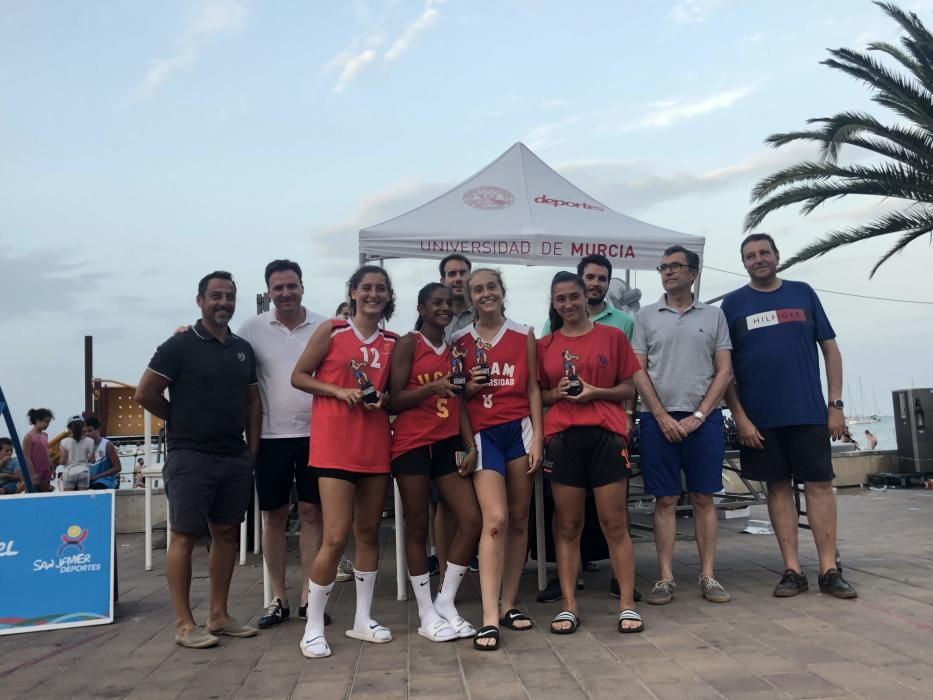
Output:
[256, 437, 321, 510]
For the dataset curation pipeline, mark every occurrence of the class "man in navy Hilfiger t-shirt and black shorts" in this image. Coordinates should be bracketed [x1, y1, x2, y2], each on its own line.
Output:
[722, 233, 857, 598]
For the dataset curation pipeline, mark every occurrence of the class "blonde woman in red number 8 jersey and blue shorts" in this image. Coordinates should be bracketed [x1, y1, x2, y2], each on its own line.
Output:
[453, 268, 544, 651]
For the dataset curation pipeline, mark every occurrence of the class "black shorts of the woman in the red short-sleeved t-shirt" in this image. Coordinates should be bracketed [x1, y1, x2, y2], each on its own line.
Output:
[544, 426, 632, 489]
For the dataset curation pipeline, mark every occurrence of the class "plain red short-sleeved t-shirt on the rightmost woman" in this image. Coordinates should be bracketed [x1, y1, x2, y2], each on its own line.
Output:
[538, 323, 641, 438]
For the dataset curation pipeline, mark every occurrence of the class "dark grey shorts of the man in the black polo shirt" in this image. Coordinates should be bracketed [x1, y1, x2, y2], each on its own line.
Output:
[162, 450, 253, 535]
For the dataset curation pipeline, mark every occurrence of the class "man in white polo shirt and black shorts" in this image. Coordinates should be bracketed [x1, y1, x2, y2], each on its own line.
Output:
[239, 260, 325, 628]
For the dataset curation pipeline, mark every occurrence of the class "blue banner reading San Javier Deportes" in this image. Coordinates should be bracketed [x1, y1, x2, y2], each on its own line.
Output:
[0, 491, 115, 635]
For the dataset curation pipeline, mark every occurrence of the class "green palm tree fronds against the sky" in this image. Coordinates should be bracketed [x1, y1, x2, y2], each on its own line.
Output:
[745, 2, 933, 277]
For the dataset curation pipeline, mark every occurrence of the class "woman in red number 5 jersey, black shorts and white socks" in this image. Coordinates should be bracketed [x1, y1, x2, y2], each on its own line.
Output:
[390, 282, 481, 642]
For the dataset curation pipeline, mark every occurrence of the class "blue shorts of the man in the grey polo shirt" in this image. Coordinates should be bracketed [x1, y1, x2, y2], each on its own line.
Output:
[639, 409, 726, 496]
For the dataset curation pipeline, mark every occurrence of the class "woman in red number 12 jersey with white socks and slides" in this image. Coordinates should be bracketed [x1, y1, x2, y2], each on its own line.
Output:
[292, 265, 398, 658]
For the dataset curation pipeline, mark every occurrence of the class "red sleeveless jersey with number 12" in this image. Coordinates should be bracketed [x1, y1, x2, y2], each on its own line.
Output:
[308, 320, 398, 474]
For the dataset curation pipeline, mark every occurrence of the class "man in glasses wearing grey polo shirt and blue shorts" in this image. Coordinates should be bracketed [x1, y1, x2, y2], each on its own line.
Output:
[632, 246, 732, 605]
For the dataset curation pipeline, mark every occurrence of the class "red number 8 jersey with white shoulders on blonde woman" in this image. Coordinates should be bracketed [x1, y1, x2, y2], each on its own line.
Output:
[453, 319, 531, 432]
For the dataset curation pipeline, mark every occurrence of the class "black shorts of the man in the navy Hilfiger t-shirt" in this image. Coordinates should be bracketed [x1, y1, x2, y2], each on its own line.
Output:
[739, 424, 836, 482]
